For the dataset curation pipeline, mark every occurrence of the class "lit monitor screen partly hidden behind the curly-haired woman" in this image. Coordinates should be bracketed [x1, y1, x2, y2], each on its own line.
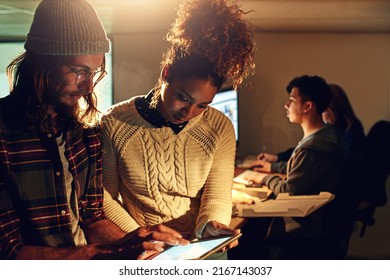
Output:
[210, 88, 238, 142]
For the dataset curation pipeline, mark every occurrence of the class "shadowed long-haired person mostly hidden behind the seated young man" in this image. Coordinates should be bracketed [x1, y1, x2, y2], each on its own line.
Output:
[322, 84, 367, 259]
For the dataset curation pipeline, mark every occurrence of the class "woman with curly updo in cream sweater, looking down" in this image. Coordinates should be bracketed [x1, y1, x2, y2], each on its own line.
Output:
[101, 0, 254, 258]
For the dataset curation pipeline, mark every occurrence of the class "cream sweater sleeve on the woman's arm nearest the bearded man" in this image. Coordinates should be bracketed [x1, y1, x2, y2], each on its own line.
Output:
[101, 116, 140, 232]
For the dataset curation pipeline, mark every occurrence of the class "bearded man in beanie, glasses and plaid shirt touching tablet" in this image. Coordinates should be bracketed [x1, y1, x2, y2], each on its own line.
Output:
[0, 0, 188, 259]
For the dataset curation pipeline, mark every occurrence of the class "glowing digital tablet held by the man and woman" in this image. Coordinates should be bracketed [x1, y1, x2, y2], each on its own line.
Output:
[150, 233, 242, 260]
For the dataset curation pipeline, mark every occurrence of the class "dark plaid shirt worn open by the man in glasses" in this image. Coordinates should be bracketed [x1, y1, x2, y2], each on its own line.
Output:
[0, 96, 106, 259]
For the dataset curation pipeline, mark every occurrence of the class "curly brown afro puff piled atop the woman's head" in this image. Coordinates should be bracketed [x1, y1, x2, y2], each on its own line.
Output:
[166, 0, 254, 87]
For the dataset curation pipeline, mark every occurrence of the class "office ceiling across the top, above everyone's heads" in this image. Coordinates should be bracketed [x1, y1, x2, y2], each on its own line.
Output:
[0, 0, 390, 40]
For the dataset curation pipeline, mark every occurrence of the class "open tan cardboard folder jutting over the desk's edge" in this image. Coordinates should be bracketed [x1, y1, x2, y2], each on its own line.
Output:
[233, 192, 334, 217]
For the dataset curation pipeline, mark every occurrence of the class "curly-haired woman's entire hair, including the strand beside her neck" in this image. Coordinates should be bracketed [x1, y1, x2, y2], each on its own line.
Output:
[151, 0, 255, 107]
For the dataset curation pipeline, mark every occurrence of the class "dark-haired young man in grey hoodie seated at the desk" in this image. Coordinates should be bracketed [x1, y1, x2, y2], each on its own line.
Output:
[244, 75, 343, 259]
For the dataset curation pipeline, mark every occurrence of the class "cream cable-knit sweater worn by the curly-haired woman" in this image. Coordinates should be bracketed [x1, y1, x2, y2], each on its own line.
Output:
[101, 98, 236, 237]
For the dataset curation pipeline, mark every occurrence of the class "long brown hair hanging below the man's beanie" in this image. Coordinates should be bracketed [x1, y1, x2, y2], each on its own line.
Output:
[7, 52, 105, 131]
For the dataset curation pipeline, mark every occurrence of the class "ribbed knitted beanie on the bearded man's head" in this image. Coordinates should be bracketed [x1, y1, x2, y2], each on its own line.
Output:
[24, 0, 109, 55]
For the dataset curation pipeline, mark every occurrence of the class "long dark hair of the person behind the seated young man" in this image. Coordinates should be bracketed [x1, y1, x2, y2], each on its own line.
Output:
[329, 84, 360, 132]
